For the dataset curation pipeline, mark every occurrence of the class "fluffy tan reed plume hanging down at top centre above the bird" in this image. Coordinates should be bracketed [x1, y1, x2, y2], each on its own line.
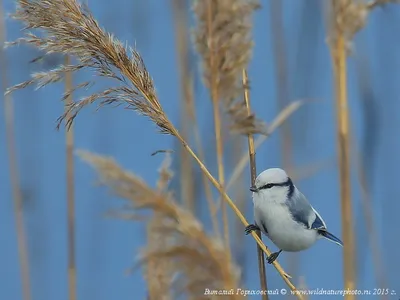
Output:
[193, 0, 265, 134]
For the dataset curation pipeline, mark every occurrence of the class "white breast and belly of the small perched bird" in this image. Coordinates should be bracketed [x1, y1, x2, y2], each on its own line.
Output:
[253, 197, 318, 252]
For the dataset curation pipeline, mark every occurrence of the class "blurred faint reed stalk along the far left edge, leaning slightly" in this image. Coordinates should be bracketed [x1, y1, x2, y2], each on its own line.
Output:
[0, 1, 32, 300]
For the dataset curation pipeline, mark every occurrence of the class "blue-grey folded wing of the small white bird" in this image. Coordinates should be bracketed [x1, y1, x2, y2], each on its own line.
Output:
[286, 192, 322, 229]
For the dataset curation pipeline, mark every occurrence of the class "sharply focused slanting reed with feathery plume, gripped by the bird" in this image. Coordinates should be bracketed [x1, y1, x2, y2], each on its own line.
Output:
[6, 0, 301, 299]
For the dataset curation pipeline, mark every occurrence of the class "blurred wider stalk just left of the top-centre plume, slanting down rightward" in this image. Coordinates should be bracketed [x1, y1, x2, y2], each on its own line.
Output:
[172, 0, 220, 234]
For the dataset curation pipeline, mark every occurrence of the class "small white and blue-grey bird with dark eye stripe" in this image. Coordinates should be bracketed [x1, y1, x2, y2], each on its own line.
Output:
[245, 168, 343, 264]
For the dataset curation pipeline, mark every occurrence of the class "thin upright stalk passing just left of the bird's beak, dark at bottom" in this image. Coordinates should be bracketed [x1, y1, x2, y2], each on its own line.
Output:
[242, 70, 268, 300]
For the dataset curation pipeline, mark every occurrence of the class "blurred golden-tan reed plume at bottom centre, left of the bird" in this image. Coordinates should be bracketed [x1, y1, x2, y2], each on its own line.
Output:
[78, 151, 242, 299]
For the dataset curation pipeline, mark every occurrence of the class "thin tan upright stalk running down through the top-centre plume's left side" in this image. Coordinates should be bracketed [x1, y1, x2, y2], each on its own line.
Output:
[207, 0, 230, 256]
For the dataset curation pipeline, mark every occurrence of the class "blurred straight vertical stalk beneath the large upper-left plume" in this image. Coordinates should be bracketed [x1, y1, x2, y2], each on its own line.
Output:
[65, 56, 76, 300]
